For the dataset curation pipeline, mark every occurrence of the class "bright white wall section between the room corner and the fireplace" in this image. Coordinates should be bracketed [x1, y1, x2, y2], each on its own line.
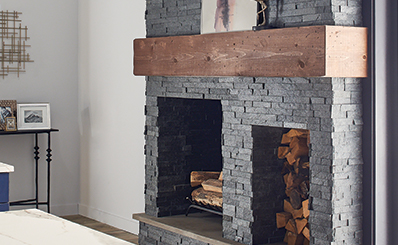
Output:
[79, 0, 145, 234]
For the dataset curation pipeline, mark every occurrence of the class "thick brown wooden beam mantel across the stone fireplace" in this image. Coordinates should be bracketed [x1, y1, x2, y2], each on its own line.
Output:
[134, 26, 367, 77]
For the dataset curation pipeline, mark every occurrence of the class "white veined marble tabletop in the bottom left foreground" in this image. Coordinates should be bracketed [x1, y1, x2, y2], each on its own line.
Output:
[0, 209, 131, 245]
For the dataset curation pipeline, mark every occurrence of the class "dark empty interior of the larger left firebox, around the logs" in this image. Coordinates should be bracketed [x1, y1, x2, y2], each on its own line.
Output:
[157, 97, 222, 217]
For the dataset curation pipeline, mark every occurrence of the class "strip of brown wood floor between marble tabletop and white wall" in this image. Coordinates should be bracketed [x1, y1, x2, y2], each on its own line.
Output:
[62, 215, 138, 244]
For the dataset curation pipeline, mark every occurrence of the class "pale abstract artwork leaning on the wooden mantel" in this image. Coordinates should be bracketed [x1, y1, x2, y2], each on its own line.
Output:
[201, 0, 257, 34]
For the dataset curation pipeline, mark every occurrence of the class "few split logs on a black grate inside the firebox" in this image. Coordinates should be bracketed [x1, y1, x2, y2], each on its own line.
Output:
[191, 171, 222, 208]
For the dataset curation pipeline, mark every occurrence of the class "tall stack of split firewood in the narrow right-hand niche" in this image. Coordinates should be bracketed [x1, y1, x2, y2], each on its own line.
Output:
[276, 129, 310, 245]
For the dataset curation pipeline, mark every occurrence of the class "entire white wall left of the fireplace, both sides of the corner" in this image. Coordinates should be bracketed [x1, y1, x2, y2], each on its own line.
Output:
[0, 0, 145, 233]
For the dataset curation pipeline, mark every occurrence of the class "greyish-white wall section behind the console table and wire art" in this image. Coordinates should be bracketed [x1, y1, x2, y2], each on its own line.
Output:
[0, 0, 80, 215]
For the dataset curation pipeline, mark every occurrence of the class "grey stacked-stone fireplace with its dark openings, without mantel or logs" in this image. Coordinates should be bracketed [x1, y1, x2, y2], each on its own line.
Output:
[135, 0, 363, 245]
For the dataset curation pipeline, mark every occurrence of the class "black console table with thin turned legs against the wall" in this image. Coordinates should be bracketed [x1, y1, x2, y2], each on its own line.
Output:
[0, 128, 59, 212]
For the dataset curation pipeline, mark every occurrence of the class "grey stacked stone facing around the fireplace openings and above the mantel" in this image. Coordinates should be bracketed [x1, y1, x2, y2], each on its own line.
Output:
[140, 0, 363, 245]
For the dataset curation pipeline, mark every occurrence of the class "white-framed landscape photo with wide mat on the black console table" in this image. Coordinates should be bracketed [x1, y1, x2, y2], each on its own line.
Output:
[17, 103, 51, 130]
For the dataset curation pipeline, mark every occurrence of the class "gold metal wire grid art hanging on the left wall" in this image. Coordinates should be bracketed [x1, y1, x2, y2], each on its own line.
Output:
[0, 11, 33, 79]
